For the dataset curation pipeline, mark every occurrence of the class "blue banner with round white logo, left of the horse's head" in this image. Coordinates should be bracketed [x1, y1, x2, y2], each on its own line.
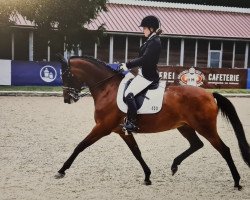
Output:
[11, 61, 62, 86]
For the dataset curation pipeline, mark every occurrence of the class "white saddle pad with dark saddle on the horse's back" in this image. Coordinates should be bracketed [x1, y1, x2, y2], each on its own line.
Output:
[117, 72, 166, 114]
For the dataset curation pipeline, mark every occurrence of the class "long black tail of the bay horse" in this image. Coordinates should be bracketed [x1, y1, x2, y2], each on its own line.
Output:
[213, 92, 250, 167]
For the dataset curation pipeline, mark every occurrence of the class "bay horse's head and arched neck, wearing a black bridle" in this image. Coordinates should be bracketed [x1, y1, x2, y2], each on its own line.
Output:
[57, 54, 123, 104]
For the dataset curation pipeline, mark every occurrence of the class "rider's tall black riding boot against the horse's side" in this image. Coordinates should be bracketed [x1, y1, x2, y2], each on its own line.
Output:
[123, 93, 138, 132]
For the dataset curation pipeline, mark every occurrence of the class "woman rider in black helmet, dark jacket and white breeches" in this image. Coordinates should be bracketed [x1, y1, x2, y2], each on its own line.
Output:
[120, 15, 162, 132]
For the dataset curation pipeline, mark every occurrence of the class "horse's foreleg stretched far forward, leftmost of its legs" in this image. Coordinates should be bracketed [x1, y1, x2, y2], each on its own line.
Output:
[55, 126, 110, 178]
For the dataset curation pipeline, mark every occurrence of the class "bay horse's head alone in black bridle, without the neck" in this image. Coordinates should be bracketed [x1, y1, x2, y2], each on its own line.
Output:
[57, 54, 81, 104]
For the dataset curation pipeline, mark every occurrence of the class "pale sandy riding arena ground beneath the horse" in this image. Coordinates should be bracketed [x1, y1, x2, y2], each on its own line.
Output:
[0, 96, 250, 200]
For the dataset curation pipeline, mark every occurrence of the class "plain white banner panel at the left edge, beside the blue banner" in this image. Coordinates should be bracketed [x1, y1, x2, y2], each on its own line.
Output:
[0, 60, 11, 85]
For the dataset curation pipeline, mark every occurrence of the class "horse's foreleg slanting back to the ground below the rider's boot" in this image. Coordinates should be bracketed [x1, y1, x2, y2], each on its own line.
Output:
[120, 134, 151, 185]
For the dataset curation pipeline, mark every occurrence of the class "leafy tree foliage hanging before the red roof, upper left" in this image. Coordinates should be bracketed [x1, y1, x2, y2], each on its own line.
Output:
[0, 0, 106, 49]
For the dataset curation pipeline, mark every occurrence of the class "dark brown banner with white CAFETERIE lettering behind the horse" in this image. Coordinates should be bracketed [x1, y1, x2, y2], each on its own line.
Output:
[159, 66, 246, 89]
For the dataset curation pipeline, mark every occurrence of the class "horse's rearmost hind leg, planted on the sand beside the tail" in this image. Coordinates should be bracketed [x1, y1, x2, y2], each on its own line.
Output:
[204, 132, 242, 190]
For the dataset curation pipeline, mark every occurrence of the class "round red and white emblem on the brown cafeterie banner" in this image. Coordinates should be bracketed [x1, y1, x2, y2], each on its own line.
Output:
[178, 67, 205, 86]
